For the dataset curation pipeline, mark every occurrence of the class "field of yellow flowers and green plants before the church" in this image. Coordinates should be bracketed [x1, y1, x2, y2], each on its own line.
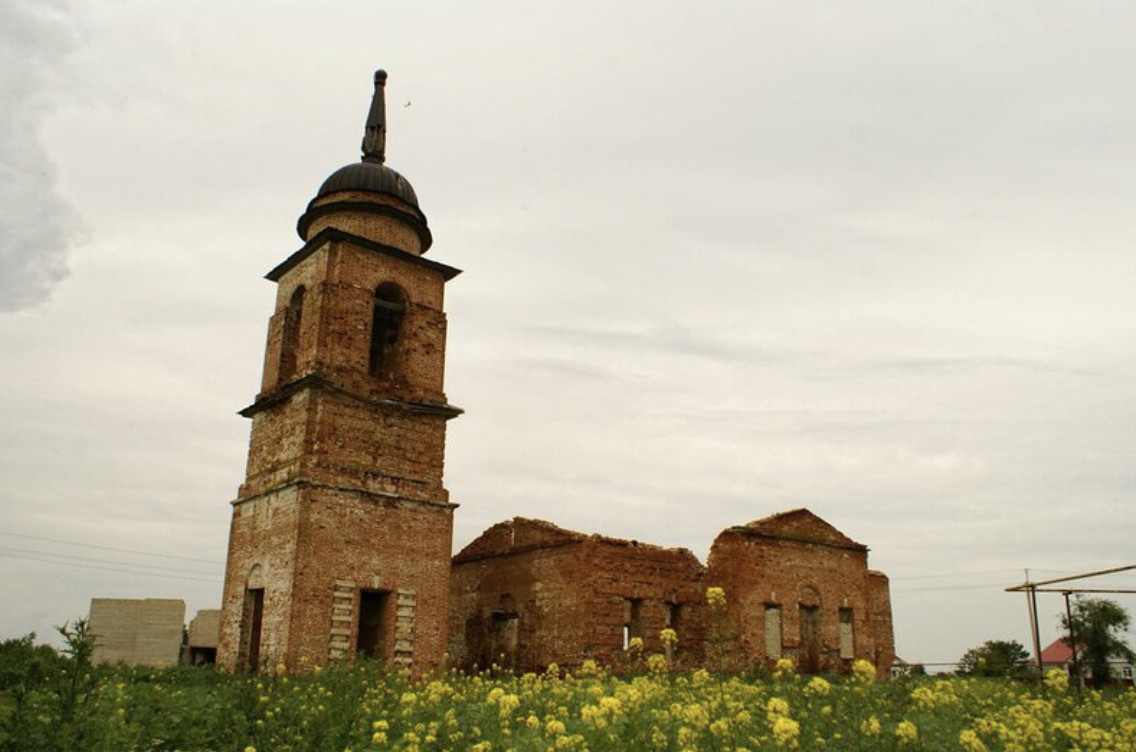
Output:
[0, 660, 1136, 752]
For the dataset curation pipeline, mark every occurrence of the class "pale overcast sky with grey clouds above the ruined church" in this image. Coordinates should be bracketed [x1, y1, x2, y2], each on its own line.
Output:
[0, 0, 1136, 661]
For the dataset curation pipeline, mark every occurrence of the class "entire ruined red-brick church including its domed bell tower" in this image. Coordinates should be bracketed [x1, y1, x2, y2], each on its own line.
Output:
[217, 72, 894, 674]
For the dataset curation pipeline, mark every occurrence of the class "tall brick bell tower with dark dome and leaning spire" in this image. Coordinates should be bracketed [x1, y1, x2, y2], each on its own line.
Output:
[217, 70, 461, 674]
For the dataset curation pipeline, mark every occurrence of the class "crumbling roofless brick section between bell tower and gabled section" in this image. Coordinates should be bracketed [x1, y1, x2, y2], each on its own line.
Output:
[450, 518, 702, 670]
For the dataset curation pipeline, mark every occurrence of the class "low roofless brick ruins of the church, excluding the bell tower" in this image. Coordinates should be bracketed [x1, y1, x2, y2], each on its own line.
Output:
[450, 510, 894, 676]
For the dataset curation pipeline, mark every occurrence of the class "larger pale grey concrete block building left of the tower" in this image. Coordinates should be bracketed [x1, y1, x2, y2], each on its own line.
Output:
[87, 598, 185, 667]
